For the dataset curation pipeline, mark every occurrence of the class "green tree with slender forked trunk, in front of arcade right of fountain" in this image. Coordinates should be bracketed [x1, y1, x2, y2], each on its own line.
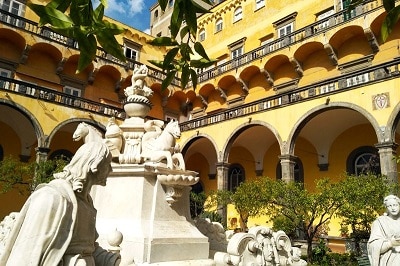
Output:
[264, 178, 342, 261]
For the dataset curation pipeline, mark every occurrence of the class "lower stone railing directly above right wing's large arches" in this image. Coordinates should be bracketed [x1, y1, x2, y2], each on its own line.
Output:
[180, 57, 400, 131]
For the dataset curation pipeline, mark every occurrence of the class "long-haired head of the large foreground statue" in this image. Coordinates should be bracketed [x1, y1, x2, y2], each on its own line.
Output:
[54, 142, 112, 192]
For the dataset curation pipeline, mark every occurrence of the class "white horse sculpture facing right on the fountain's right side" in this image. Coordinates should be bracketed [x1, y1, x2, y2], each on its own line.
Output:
[140, 120, 186, 171]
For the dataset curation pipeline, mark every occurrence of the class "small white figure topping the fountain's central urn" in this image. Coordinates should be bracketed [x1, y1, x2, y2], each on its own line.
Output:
[124, 65, 153, 102]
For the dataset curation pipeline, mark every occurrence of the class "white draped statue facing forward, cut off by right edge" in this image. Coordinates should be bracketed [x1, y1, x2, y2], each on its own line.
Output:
[367, 195, 400, 266]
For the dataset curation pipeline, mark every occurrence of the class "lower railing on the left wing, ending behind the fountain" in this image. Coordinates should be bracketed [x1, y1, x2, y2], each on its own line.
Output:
[0, 76, 125, 119]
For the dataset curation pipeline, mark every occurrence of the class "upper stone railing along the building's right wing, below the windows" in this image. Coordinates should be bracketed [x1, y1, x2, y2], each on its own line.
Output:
[198, 0, 383, 83]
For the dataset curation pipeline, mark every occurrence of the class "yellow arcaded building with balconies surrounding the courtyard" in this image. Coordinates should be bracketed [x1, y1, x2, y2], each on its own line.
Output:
[0, 0, 400, 245]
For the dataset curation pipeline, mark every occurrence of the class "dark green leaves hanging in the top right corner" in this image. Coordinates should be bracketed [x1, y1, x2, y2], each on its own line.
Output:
[349, 0, 400, 42]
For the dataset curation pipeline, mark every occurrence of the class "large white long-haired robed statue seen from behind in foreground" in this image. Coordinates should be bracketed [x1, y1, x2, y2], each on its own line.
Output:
[0, 142, 120, 266]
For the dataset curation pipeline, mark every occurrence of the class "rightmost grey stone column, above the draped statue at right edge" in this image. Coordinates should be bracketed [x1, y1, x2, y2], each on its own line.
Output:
[375, 142, 398, 184]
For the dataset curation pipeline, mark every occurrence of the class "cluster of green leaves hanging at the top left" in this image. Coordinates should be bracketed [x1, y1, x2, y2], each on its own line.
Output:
[28, 0, 126, 72]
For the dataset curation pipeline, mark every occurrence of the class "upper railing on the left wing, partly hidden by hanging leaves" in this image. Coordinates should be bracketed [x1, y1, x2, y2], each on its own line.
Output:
[0, 9, 180, 86]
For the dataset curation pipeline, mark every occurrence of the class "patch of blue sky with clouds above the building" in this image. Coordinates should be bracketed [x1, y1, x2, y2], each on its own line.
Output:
[101, 0, 157, 33]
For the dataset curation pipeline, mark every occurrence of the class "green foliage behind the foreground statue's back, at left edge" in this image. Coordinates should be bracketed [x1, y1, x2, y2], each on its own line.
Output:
[0, 156, 66, 194]
